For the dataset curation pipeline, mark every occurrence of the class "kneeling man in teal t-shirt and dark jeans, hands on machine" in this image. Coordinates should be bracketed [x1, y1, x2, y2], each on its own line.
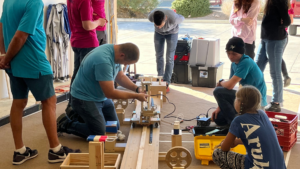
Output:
[57, 43, 146, 138]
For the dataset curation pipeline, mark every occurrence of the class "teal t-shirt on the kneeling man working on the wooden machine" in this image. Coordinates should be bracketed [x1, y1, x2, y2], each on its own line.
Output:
[71, 44, 122, 102]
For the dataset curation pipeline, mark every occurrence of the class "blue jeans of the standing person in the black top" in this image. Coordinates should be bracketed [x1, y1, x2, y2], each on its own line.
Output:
[255, 39, 287, 103]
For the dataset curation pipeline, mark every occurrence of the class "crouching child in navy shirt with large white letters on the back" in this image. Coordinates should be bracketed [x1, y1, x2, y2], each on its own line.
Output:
[213, 86, 286, 169]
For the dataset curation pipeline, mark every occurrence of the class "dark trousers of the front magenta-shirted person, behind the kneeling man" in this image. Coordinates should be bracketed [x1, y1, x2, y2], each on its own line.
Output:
[68, 47, 95, 107]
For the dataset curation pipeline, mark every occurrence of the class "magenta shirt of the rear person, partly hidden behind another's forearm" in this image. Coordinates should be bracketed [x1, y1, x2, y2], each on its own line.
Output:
[92, 0, 106, 31]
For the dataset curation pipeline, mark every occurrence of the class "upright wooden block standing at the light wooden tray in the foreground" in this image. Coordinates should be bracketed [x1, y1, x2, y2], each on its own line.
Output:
[89, 142, 104, 169]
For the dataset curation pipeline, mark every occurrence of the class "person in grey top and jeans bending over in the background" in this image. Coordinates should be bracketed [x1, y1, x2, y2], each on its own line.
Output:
[148, 8, 184, 93]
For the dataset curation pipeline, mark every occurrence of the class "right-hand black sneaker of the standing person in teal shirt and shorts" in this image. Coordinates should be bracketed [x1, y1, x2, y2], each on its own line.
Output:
[48, 146, 80, 163]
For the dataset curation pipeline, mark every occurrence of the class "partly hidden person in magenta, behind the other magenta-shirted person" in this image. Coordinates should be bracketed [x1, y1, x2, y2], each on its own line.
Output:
[92, 0, 107, 45]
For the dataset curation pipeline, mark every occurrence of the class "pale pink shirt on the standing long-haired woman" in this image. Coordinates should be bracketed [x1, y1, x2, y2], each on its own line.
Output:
[229, 0, 260, 44]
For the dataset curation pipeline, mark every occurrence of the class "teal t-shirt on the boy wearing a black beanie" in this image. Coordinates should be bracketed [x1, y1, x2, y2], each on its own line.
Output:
[230, 55, 267, 106]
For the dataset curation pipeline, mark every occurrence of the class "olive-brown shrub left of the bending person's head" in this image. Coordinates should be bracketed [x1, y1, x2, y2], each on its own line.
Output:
[117, 0, 159, 18]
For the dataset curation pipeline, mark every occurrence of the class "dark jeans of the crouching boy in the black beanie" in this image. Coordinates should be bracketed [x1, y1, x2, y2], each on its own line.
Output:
[214, 87, 237, 126]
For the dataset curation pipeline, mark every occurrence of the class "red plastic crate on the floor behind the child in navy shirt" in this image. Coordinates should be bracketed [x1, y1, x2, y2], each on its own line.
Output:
[266, 112, 298, 151]
